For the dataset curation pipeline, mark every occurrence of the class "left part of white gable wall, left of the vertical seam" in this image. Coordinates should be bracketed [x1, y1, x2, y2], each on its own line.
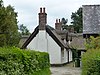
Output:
[27, 30, 47, 52]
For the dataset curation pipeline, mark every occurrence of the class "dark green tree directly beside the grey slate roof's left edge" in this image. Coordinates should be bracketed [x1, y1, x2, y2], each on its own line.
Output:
[71, 7, 83, 33]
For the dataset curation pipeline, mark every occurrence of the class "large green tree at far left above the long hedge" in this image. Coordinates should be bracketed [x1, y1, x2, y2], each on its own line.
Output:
[0, 1, 19, 46]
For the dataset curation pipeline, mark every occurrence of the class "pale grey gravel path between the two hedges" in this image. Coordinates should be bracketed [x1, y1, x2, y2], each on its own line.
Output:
[50, 66, 81, 75]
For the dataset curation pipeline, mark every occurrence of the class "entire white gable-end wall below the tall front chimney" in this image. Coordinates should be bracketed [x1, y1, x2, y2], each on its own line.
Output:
[27, 30, 61, 64]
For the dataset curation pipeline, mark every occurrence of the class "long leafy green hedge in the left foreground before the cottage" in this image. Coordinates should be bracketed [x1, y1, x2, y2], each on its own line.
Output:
[0, 47, 50, 75]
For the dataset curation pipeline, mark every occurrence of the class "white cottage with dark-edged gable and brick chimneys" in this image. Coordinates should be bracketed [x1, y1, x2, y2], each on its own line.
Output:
[22, 8, 72, 65]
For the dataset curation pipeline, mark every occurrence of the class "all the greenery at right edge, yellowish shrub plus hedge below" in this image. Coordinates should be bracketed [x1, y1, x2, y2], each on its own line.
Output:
[82, 36, 100, 75]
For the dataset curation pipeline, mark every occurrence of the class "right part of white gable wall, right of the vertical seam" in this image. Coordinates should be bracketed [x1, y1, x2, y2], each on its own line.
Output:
[47, 33, 62, 64]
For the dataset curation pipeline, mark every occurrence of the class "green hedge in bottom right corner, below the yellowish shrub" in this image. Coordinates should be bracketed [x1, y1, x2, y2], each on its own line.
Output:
[82, 49, 100, 75]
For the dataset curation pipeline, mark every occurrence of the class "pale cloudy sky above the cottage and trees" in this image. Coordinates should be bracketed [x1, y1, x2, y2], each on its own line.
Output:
[3, 0, 100, 32]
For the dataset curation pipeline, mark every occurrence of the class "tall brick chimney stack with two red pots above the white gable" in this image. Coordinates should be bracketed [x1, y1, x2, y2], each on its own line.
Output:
[38, 8, 47, 30]
